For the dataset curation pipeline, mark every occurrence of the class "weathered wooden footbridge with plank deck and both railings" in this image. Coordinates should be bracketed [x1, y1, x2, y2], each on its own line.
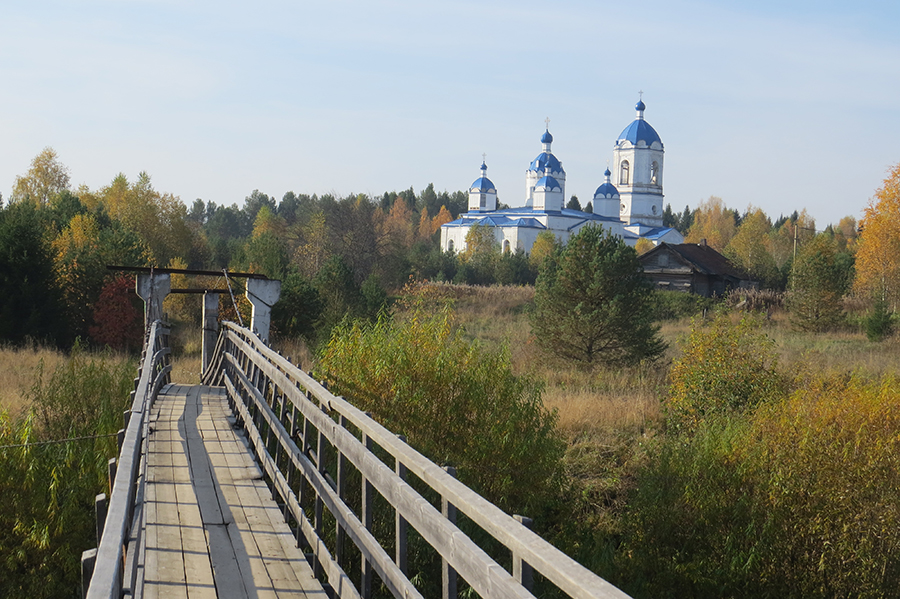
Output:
[82, 274, 627, 599]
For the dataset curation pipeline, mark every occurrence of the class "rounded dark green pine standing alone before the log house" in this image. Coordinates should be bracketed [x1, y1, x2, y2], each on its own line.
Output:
[531, 226, 665, 365]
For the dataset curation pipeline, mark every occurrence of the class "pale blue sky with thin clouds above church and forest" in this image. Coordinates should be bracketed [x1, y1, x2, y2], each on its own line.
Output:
[0, 0, 900, 228]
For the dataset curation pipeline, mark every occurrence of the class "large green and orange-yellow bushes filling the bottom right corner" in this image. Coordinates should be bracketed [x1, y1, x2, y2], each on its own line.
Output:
[619, 375, 900, 598]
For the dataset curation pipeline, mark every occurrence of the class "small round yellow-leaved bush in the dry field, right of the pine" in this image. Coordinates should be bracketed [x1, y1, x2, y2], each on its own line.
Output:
[666, 312, 786, 432]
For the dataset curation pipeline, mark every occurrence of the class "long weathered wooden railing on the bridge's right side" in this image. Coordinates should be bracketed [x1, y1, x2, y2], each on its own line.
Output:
[204, 323, 627, 599]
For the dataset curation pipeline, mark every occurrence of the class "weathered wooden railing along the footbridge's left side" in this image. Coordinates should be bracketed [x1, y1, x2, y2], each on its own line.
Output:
[82, 321, 172, 599]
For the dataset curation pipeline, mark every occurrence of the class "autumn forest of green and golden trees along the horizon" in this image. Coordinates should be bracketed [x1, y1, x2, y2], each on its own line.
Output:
[0, 148, 900, 347]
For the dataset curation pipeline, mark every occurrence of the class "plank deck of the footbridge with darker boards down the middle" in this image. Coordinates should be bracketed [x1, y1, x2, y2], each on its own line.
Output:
[135, 385, 326, 599]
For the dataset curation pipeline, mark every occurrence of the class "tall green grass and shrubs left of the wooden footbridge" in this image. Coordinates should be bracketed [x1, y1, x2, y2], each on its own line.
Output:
[0, 348, 136, 598]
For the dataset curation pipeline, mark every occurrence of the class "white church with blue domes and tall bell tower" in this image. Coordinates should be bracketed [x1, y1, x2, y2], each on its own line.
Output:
[441, 101, 684, 253]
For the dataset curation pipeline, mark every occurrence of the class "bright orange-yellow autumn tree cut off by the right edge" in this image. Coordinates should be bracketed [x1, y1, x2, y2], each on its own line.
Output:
[854, 163, 900, 305]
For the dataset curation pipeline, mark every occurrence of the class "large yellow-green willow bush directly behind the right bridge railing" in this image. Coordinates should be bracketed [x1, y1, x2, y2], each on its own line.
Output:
[319, 308, 564, 513]
